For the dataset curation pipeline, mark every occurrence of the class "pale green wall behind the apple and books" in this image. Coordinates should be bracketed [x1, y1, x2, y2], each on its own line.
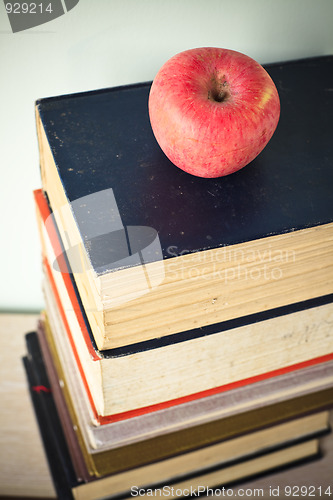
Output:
[0, 0, 333, 310]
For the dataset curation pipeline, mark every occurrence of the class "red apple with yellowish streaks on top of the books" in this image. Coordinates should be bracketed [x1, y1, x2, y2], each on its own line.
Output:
[148, 47, 280, 178]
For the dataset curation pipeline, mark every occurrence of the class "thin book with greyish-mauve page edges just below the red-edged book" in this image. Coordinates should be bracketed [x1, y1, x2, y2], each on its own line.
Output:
[37, 304, 333, 453]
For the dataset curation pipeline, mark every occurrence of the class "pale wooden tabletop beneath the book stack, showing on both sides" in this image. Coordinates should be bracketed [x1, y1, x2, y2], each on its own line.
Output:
[0, 314, 333, 498]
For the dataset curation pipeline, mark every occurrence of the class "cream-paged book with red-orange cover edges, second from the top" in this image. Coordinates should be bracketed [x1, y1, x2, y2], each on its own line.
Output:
[35, 191, 333, 421]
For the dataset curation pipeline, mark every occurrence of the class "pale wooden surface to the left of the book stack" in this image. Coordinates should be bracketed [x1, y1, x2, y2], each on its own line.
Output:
[0, 314, 55, 498]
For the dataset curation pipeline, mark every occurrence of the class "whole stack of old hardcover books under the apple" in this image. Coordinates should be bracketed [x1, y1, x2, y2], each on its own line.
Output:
[24, 52, 333, 499]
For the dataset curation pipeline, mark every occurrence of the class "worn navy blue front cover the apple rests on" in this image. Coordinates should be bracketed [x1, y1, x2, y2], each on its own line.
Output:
[37, 56, 333, 258]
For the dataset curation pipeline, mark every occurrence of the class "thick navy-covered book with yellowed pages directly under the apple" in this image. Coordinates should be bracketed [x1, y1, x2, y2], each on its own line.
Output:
[36, 56, 333, 349]
